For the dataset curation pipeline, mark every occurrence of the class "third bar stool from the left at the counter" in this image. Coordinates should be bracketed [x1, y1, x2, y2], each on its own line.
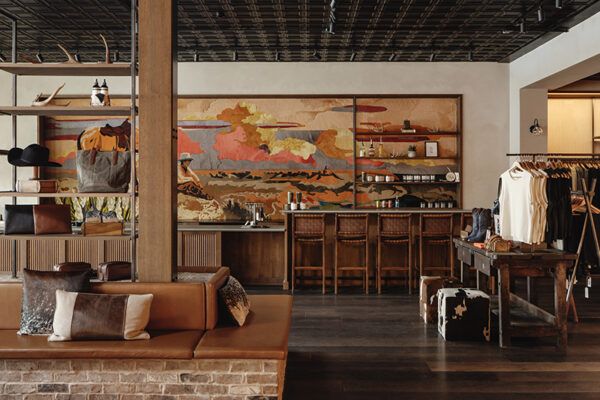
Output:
[377, 214, 413, 294]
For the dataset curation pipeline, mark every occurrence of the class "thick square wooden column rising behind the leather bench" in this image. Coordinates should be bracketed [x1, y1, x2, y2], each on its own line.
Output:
[137, 0, 177, 282]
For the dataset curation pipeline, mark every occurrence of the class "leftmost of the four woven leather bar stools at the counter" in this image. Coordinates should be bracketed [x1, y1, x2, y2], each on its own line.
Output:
[292, 214, 326, 294]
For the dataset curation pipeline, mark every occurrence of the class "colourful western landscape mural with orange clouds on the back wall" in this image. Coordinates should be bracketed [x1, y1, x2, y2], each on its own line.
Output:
[42, 97, 458, 221]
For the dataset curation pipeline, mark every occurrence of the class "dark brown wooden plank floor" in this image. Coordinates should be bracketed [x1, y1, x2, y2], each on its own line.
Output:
[284, 292, 600, 400]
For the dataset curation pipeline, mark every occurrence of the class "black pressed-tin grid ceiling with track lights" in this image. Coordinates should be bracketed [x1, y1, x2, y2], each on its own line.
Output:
[0, 0, 600, 62]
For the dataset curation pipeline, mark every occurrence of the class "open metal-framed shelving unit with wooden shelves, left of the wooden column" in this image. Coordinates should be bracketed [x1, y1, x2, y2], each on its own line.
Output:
[0, 0, 137, 280]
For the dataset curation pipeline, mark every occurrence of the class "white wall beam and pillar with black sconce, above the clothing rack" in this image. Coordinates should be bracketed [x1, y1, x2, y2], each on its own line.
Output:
[509, 13, 600, 152]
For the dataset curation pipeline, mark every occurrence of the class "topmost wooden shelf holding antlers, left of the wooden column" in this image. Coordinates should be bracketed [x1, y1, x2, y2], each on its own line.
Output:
[0, 63, 131, 77]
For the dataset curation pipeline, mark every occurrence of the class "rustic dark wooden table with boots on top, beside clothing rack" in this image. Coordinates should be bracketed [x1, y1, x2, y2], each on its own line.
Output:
[454, 239, 576, 351]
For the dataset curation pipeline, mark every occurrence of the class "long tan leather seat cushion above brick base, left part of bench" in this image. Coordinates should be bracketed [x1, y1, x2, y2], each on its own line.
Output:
[0, 330, 203, 359]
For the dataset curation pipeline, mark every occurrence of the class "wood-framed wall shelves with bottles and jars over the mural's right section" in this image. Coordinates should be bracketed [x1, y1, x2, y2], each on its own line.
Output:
[353, 95, 464, 209]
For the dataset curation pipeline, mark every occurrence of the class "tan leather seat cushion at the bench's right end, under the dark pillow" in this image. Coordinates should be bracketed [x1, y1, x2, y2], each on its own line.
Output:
[194, 295, 292, 360]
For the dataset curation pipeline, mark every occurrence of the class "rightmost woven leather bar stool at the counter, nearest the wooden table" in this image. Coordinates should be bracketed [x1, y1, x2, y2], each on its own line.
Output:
[418, 213, 454, 276]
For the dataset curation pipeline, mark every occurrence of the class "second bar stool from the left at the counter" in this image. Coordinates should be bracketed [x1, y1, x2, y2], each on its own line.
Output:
[334, 214, 369, 294]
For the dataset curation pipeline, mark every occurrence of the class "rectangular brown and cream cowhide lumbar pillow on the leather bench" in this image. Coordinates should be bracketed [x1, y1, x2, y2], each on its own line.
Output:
[48, 290, 154, 342]
